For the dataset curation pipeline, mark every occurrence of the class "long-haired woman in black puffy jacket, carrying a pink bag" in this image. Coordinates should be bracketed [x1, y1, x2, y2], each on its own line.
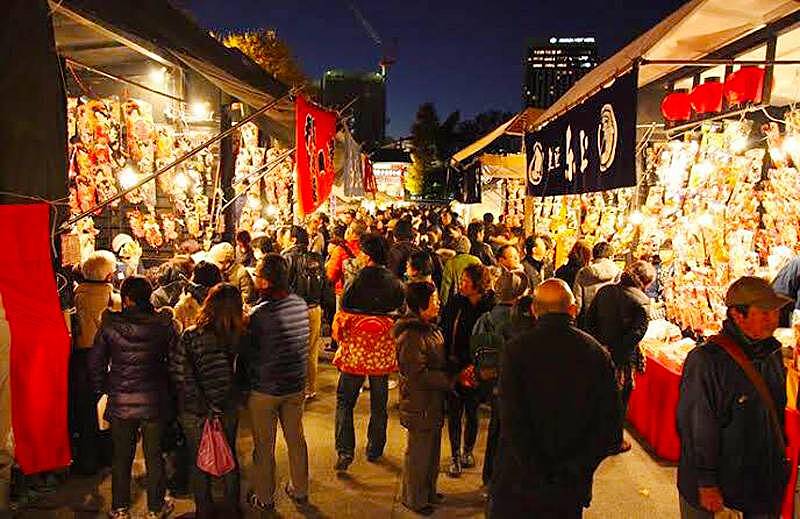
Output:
[169, 283, 245, 518]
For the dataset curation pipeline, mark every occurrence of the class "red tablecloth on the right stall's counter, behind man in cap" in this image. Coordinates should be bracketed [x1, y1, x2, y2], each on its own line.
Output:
[628, 355, 800, 519]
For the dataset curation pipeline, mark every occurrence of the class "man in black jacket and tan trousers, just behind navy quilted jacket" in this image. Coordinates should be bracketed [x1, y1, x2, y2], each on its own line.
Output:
[283, 225, 333, 398]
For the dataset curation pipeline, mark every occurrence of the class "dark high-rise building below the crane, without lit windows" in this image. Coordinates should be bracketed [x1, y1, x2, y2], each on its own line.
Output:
[322, 70, 386, 148]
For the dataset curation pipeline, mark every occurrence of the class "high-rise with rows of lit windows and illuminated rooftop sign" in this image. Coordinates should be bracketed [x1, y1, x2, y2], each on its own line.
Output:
[522, 36, 597, 108]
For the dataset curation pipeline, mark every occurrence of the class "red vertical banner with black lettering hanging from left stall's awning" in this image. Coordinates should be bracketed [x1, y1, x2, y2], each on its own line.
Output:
[295, 96, 336, 214]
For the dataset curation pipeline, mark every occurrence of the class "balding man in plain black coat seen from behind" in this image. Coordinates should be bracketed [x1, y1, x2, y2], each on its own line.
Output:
[488, 279, 622, 519]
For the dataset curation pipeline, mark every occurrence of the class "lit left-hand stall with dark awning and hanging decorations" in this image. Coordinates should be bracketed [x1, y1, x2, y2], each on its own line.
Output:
[52, 0, 294, 270]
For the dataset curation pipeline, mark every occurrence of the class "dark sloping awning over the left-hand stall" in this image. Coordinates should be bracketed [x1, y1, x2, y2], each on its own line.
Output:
[50, 0, 294, 142]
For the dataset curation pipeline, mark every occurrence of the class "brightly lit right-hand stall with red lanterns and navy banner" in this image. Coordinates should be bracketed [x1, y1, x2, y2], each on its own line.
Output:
[526, 0, 800, 517]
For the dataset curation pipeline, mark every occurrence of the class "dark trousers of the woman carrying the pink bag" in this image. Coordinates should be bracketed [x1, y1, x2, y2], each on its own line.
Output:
[179, 411, 239, 517]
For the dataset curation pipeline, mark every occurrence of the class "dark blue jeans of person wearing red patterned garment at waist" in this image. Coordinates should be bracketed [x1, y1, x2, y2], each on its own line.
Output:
[336, 373, 389, 458]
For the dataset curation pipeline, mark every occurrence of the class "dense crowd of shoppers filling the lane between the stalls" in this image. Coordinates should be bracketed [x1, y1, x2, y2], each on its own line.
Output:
[57, 204, 785, 518]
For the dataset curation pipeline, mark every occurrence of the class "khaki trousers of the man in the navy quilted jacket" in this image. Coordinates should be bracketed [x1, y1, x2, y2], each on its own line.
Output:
[247, 391, 308, 504]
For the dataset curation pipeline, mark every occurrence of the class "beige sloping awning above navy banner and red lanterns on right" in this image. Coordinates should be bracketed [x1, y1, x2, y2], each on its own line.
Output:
[536, 0, 800, 131]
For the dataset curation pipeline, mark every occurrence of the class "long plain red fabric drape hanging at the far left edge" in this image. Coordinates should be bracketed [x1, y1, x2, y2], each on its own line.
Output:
[0, 204, 71, 474]
